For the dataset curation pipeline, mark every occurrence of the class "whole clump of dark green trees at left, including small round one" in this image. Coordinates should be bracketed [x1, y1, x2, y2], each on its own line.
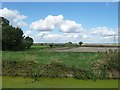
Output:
[0, 17, 34, 51]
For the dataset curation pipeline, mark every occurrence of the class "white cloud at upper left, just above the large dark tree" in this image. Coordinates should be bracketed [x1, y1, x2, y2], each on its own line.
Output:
[0, 8, 27, 28]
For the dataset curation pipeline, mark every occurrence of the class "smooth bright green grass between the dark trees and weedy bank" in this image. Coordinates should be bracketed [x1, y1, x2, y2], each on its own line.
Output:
[2, 46, 99, 68]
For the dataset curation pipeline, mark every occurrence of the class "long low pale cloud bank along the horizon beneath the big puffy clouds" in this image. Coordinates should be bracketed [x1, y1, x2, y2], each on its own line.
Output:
[35, 27, 118, 43]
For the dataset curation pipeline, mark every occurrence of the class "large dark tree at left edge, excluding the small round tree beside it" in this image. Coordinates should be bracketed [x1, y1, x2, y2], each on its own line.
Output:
[2, 18, 23, 50]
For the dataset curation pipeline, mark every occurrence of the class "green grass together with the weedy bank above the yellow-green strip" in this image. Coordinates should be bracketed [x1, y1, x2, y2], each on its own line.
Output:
[2, 47, 119, 80]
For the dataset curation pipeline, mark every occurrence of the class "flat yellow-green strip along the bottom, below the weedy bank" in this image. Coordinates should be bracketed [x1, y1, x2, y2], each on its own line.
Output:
[2, 76, 118, 88]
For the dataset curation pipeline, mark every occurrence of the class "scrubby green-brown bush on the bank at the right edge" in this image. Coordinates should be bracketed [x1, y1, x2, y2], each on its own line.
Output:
[92, 50, 120, 79]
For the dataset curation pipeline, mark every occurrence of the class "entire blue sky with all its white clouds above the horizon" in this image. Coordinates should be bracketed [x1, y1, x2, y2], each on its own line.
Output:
[0, 2, 118, 43]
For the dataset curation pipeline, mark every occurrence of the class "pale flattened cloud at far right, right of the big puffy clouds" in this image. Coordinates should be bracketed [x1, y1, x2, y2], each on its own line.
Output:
[90, 27, 116, 36]
